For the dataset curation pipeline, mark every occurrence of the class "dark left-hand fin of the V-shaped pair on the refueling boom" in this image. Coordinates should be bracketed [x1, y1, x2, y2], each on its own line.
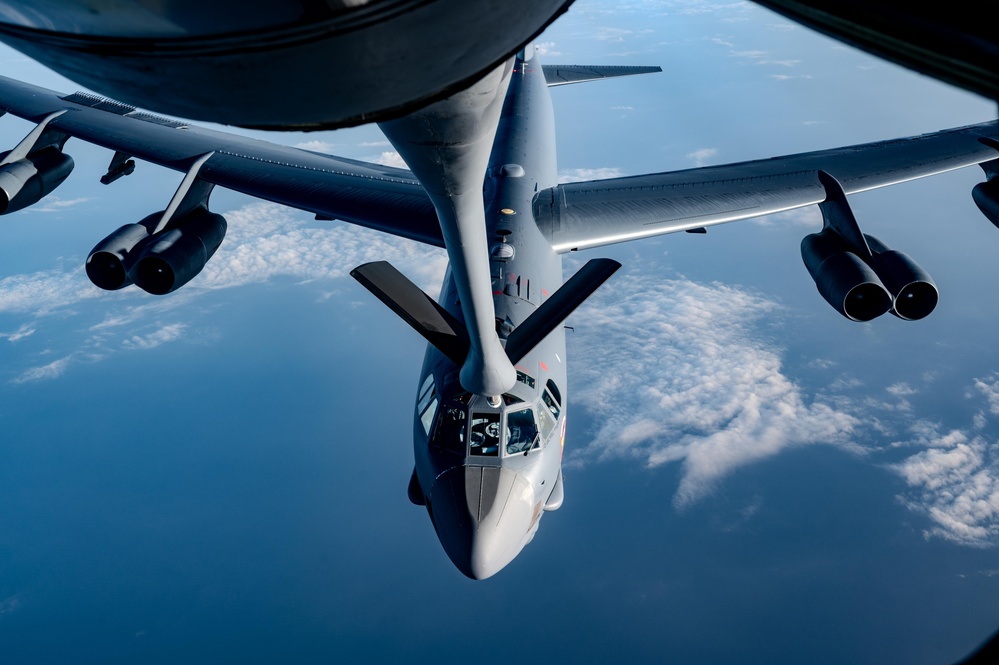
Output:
[350, 261, 470, 365]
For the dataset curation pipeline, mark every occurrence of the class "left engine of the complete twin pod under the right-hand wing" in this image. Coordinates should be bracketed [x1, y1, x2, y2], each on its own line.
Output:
[801, 230, 892, 321]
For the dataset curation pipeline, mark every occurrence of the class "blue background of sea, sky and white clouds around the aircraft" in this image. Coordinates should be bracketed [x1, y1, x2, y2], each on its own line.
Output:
[0, 0, 999, 664]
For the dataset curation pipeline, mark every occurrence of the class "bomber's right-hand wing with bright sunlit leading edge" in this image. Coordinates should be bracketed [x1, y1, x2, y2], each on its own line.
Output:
[534, 121, 999, 252]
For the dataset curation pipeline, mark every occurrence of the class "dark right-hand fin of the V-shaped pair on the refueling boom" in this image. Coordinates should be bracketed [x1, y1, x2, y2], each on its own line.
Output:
[506, 259, 621, 365]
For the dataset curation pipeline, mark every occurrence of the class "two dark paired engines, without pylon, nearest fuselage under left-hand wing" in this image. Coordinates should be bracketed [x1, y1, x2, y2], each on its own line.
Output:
[86, 206, 227, 295]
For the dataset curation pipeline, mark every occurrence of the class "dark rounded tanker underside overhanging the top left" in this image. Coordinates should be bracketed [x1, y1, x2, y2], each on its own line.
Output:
[0, 0, 572, 129]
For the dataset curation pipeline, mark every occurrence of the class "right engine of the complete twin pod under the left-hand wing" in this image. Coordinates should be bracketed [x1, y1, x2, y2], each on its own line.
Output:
[128, 207, 227, 296]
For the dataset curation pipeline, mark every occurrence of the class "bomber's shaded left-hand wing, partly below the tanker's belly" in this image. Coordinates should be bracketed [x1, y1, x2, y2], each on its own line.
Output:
[0, 76, 444, 247]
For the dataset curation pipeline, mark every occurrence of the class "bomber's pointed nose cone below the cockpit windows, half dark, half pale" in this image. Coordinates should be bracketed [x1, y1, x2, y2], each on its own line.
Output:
[430, 466, 541, 580]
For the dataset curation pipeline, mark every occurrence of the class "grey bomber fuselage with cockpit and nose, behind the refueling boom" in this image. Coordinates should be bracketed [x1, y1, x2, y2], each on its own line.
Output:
[398, 52, 566, 579]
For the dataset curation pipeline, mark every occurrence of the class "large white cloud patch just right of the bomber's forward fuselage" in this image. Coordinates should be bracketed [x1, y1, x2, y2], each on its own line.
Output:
[571, 275, 859, 507]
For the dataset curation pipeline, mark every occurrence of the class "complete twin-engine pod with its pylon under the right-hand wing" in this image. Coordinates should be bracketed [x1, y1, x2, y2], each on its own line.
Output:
[801, 172, 939, 321]
